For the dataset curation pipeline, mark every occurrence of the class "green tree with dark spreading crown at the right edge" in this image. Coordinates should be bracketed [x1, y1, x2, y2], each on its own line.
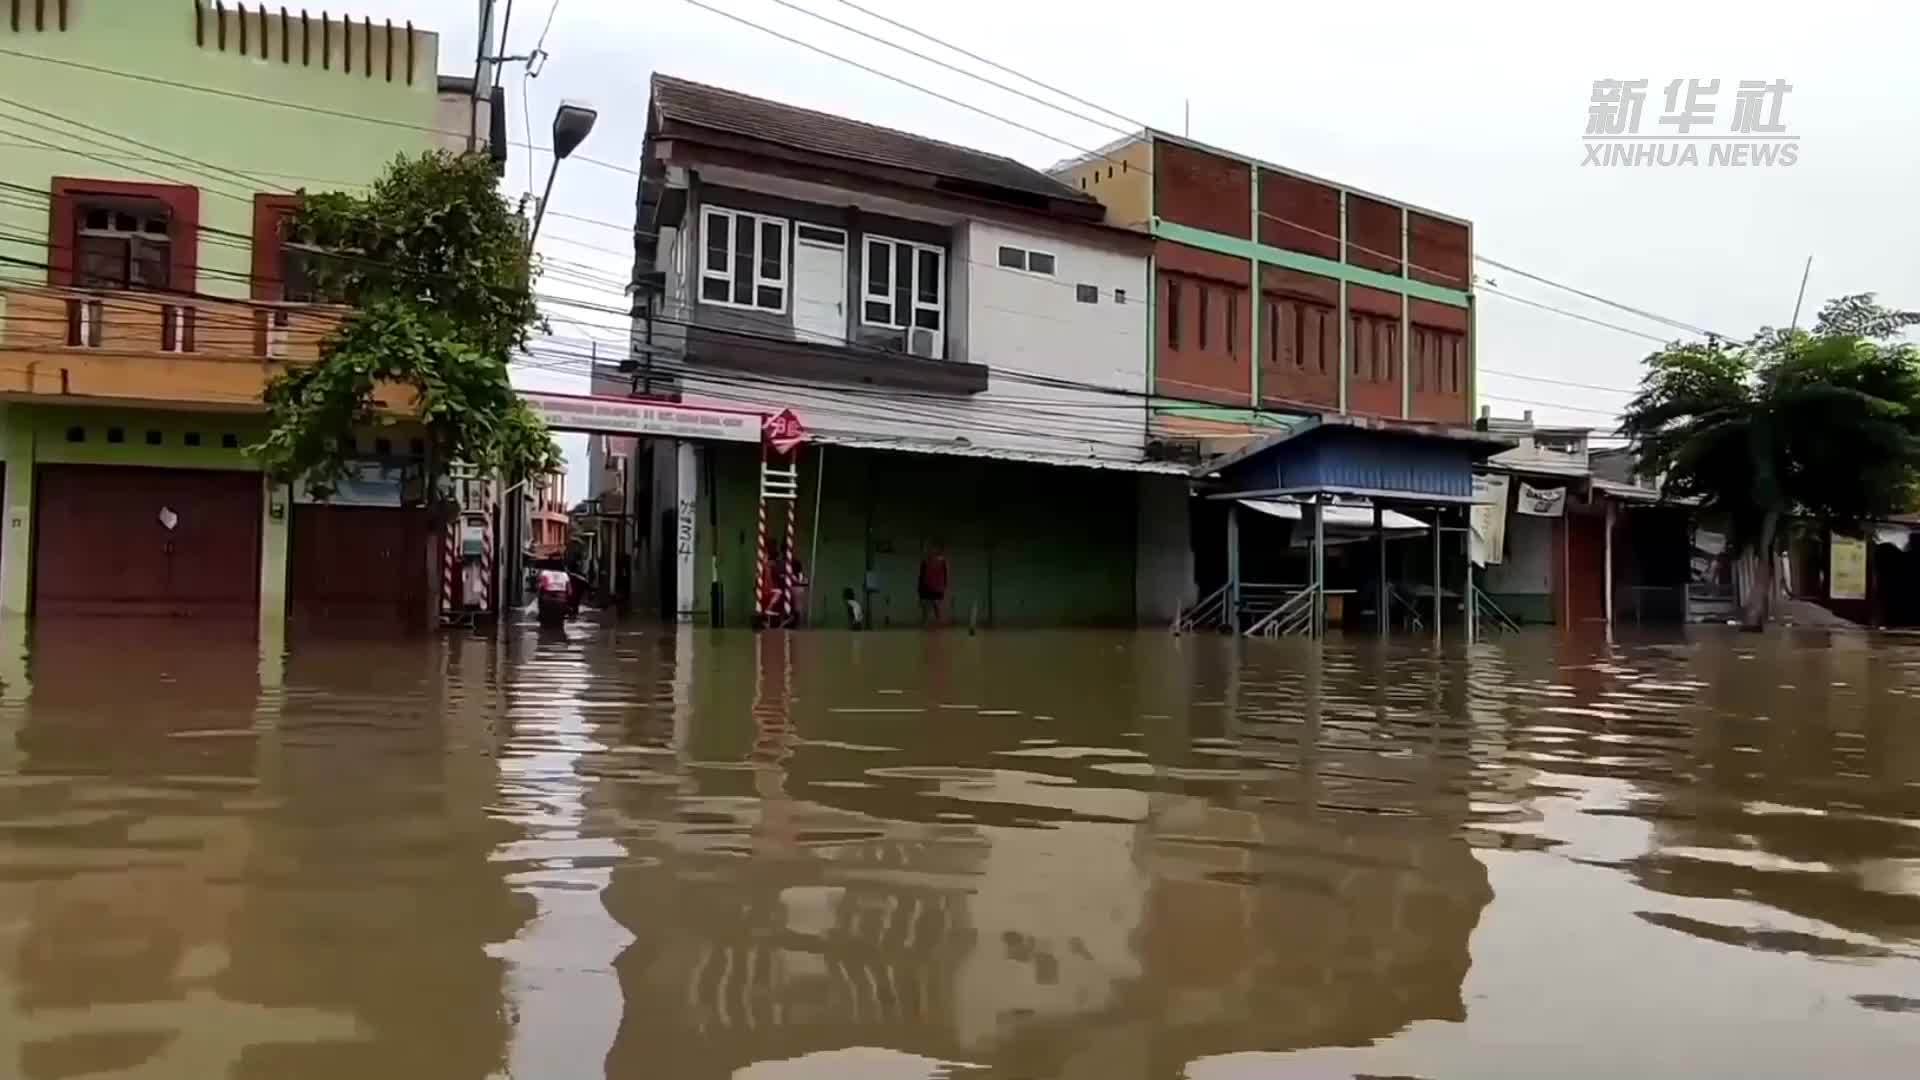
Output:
[1620, 294, 1920, 628]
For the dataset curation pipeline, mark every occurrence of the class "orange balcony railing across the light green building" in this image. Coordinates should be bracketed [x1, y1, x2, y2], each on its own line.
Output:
[0, 282, 344, 363]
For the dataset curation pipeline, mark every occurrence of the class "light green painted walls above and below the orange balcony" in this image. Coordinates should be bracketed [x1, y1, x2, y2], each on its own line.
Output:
[0, 0, 447, 626]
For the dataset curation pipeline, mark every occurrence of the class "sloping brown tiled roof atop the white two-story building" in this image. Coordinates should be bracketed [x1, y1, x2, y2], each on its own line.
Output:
[653, 75, 1098, 204]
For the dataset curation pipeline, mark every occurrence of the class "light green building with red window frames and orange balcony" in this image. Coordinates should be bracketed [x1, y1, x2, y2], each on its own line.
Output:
[0, 0, 501, 636]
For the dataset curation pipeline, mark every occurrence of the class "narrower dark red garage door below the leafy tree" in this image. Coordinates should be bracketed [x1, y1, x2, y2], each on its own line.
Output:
[288, 505, 432, 630]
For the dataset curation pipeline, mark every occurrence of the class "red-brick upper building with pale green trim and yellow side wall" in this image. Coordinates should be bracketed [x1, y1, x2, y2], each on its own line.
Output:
[1054, 131, 1475, 442]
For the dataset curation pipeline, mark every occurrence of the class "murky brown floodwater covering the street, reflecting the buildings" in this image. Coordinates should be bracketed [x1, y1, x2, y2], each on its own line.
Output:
[0, 625, 1920, 1080]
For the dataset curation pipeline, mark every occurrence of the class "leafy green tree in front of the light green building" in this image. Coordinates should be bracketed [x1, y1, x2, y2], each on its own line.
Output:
[253, 152, 559, 492]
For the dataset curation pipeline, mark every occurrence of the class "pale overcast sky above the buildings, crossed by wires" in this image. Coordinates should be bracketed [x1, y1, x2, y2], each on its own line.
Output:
[382, 0, 1920, 482]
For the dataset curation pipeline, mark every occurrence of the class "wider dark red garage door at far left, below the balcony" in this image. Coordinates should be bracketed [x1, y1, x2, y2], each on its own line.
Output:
[33, 465, 261, 619]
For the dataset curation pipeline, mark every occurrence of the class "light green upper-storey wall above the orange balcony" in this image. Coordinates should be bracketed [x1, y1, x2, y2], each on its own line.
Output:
[0, 0, 438, 296]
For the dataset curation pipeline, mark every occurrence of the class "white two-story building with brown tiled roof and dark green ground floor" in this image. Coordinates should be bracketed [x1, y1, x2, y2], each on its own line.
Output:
[589, 75, 1192, 625]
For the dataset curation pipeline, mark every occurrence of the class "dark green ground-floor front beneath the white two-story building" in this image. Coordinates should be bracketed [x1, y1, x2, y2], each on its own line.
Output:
[699, 444, 1139, 626]
